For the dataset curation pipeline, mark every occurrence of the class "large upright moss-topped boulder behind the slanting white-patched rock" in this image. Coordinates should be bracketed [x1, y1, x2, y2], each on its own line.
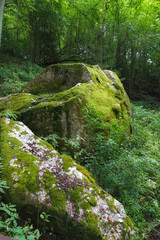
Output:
[19, 63, 131, 138]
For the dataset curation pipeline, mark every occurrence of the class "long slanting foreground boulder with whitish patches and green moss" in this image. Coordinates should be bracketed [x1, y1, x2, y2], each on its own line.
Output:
[0, 118, 134, 240]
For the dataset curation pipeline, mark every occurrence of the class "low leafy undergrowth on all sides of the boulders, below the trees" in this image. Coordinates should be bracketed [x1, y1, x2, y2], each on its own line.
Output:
[0, 55, 160, 240]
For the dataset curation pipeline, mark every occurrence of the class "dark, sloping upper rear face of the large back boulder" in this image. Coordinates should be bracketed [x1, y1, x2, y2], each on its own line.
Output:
[23, 63, 92, 94]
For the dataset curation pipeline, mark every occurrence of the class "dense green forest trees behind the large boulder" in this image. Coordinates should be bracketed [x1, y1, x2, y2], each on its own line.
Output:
[1, 0, 160, 95]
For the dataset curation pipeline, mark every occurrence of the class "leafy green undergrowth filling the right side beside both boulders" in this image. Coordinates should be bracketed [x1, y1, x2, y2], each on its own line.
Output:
[52, 97, 160, 240]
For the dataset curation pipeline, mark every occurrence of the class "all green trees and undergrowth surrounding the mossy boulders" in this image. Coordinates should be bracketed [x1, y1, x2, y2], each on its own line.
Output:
[0, 0, 160, 240]
